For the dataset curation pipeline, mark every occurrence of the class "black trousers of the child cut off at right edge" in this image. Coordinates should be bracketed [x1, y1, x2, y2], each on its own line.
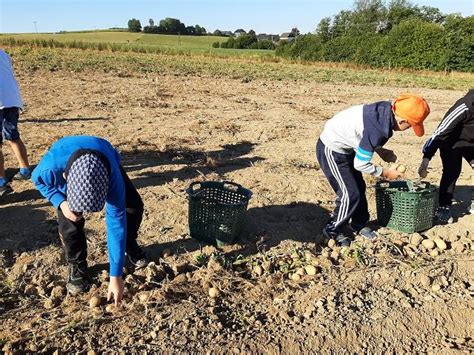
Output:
[439, 147, 474, 206]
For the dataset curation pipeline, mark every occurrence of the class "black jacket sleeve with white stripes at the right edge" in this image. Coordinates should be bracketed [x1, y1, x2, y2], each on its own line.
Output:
[423, 102, 469, 159]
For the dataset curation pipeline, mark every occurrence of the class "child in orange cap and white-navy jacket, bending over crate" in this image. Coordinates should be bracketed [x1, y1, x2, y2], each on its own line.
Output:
[316, 94, 430, 246]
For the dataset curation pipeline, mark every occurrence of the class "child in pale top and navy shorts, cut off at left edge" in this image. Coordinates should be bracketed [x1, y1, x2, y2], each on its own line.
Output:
[0, 49, 31, 196]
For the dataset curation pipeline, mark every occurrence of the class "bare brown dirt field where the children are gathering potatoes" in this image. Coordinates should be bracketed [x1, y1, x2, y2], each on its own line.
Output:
[0, 62, 474, 354]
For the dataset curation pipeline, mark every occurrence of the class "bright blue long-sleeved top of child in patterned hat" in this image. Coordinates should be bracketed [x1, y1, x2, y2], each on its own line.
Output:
[32, 136, 127, 276]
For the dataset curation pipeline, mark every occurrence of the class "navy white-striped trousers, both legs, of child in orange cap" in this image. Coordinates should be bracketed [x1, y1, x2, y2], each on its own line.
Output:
[316, 140, 370, 232]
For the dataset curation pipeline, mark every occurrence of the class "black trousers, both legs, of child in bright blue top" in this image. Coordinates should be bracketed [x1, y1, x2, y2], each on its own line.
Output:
[58, 167, 143, 268]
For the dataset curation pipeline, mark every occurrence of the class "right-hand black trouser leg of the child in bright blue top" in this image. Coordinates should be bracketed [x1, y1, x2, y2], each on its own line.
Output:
[120, 167, 144, 259]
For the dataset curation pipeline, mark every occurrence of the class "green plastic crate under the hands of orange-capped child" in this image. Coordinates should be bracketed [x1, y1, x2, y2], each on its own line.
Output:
[375, 180, 438, 233]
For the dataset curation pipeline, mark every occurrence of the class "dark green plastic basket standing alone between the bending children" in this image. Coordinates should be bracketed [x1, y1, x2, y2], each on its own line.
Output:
[187, 181, 252, 246]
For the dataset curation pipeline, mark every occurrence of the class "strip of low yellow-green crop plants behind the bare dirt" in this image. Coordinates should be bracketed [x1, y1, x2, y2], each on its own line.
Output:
[4, 45, 474, 90]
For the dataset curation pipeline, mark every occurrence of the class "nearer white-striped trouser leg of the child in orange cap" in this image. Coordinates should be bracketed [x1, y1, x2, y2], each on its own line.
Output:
[317, 141, 361, 233]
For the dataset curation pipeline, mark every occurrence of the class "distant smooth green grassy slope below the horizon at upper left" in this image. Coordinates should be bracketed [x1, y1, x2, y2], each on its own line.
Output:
[0, 31, 274, 56]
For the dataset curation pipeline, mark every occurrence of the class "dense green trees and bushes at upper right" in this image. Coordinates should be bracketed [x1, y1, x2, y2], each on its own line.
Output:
[276, 0, 474, 72]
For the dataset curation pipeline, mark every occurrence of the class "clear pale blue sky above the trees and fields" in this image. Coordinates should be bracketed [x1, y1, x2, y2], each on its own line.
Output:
[0, 0, 474, 34]
